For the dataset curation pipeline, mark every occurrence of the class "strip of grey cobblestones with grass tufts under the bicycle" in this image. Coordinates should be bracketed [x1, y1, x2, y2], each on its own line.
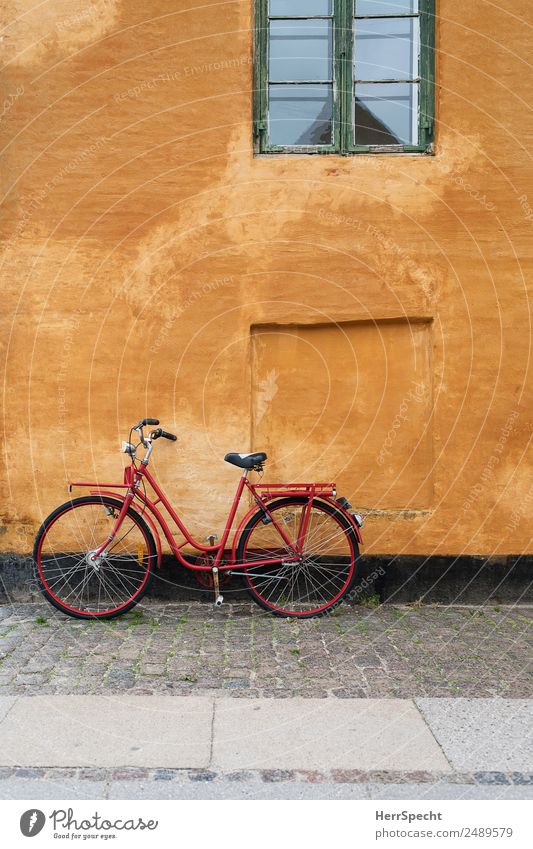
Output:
[0, 601, 533, 698]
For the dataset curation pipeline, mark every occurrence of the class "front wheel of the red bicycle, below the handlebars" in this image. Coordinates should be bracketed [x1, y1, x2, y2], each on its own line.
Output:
[33, 495, 157, 619]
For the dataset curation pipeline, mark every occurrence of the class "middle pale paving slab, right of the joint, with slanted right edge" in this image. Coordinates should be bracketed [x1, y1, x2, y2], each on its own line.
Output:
[210, 699, 451, 770]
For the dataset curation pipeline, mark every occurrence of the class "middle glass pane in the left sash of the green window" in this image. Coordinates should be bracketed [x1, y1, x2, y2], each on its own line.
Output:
[269, 20, 333, 80]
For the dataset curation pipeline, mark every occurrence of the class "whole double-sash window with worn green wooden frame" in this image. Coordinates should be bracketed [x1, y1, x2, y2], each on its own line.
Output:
[254, 0, 435, 154]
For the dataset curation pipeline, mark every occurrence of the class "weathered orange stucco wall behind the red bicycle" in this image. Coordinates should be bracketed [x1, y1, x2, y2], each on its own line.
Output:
[0, 0, 533, 554]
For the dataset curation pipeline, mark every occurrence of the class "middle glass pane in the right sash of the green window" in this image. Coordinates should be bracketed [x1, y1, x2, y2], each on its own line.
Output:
[354, 18, 419, 80]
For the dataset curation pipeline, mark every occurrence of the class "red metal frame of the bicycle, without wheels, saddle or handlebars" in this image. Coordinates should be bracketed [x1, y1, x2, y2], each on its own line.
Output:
[69, 463, 362, 572]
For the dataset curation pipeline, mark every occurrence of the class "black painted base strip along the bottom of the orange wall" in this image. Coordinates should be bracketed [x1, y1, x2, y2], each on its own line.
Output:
[0, 554, 533, 604]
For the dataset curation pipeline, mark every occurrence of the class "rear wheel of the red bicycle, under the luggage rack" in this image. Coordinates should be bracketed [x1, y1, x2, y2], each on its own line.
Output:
[237, 497, 359, 619]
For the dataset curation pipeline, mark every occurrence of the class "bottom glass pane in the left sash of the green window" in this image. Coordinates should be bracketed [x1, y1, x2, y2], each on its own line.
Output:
[268, 85, 333, 145]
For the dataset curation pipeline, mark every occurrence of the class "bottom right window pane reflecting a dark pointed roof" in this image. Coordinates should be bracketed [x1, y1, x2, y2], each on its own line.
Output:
[354, 83, 418, 144]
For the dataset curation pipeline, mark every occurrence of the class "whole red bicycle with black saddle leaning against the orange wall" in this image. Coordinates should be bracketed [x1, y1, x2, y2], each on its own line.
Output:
[33, 418, 362, 619]
